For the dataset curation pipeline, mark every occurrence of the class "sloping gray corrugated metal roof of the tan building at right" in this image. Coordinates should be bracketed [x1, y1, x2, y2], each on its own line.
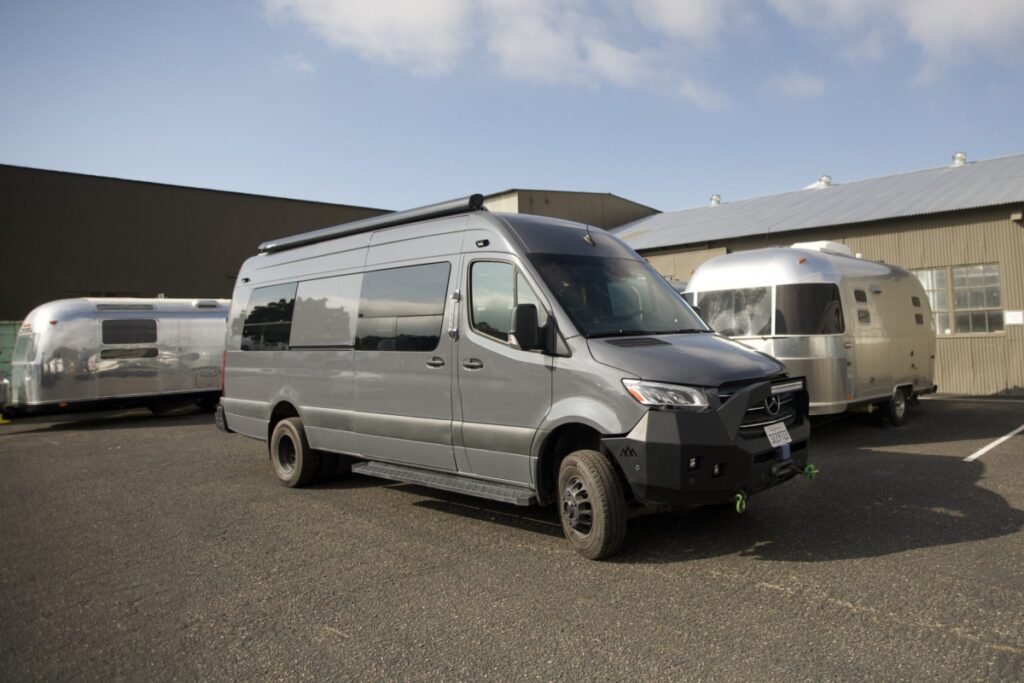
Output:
[611, 155, 1024, 250]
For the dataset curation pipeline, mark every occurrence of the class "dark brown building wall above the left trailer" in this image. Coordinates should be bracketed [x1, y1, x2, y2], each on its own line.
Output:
[0, 165, 386, 321]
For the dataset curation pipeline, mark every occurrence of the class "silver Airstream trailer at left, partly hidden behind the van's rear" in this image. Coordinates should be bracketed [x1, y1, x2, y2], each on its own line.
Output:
[0, 298, 230, 416]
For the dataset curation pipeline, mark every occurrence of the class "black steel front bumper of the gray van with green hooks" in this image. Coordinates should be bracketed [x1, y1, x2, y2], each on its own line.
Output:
[603, 381, 810, 508]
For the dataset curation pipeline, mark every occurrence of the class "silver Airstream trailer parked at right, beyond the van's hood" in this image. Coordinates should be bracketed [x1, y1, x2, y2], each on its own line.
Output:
[685, 242, 936, 425]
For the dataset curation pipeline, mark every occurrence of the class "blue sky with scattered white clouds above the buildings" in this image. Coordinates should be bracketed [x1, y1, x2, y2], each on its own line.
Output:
[0, 0, 1024, 210]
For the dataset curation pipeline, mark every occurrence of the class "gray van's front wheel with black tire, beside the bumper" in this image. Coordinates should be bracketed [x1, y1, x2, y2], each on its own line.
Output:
[558, 451, 626, 560]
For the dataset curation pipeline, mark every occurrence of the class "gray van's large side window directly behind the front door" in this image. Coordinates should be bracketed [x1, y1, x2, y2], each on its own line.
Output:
[355, 263, 452, 351]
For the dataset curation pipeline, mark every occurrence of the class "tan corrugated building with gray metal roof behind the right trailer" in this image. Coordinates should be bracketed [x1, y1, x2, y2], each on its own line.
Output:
[612, 149, 1024, 395]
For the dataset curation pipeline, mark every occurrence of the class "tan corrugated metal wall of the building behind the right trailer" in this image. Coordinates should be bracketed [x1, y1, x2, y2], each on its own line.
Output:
[645, 206, 1024, 395]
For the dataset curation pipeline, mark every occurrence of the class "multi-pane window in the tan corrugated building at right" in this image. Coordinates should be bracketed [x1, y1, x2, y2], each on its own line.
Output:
[914, 263, 1002, 335]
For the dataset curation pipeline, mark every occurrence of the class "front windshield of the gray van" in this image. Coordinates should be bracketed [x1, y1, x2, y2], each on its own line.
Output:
[530, 254, 710, 337]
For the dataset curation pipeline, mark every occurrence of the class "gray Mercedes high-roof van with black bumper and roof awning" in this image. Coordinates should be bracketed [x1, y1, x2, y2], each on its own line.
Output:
[217, 195, 813, 559]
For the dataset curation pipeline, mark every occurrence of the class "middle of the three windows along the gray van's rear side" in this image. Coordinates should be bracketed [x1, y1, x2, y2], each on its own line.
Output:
[290, 274, 362, 348]
